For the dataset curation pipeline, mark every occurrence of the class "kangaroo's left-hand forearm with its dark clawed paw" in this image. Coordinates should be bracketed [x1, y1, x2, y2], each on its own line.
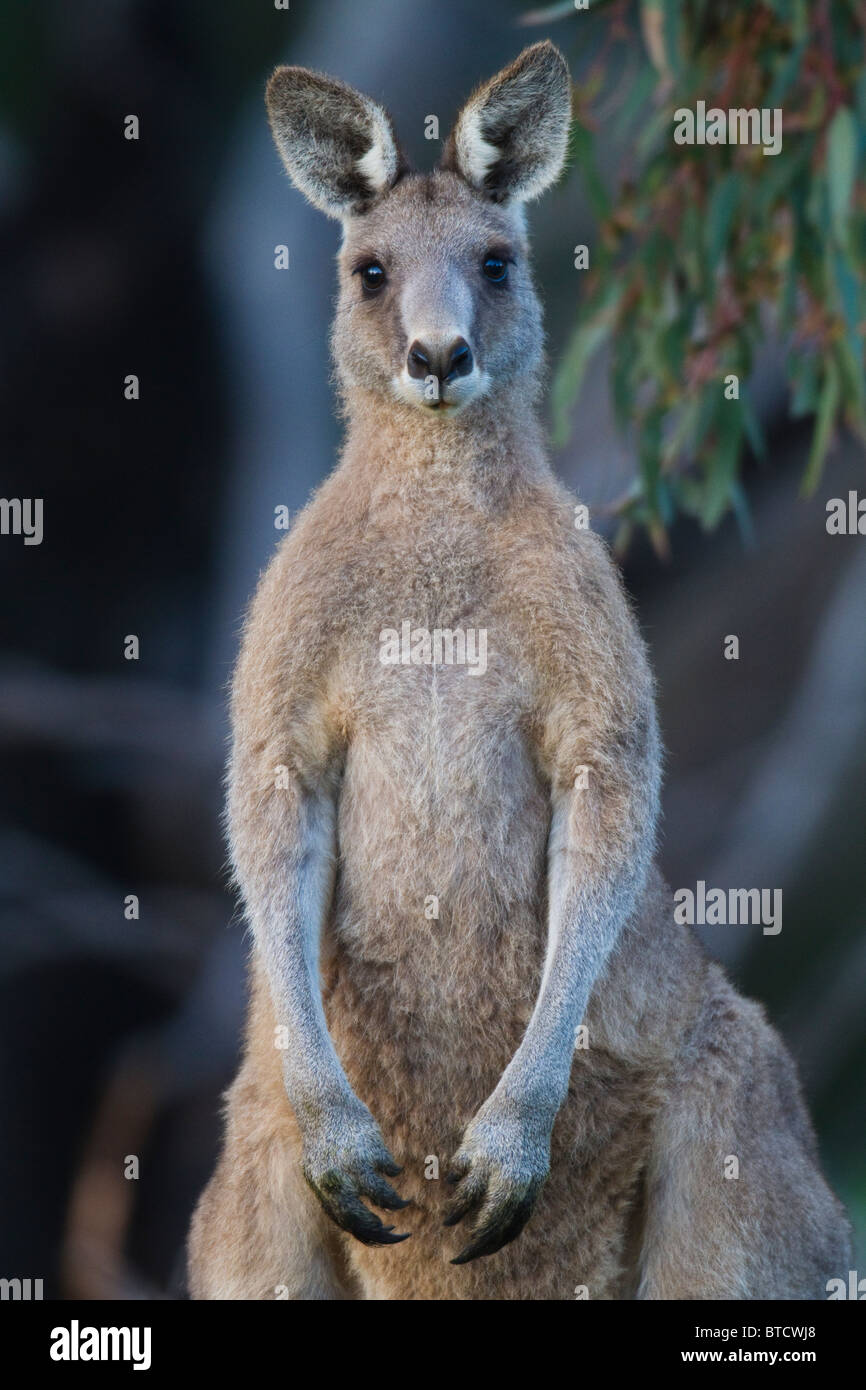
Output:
[229, 761, 405, 1245]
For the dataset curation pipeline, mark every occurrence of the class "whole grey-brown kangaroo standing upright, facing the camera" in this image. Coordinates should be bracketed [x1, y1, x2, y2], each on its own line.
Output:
[189, 43, 849, 1300]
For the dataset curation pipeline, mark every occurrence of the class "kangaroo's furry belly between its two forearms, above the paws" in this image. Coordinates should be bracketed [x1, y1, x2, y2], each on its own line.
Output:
[325, 673, 549, 1131]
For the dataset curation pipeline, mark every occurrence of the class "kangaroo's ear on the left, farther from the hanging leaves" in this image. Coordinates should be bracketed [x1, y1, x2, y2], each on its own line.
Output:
[265, 67, 406, 218]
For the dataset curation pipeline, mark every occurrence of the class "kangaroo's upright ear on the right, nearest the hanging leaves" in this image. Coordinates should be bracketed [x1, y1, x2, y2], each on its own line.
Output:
[442, 40, 571, 203]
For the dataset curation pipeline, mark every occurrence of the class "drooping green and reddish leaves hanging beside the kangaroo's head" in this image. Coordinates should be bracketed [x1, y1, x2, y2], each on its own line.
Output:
[527, 0, 866, 552]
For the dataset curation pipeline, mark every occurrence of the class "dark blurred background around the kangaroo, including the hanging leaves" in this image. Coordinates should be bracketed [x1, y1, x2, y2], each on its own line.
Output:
[0, 0, 866, 1298]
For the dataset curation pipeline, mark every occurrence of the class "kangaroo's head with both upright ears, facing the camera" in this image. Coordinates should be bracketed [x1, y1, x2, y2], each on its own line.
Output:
[267, 43, 571, 416]
